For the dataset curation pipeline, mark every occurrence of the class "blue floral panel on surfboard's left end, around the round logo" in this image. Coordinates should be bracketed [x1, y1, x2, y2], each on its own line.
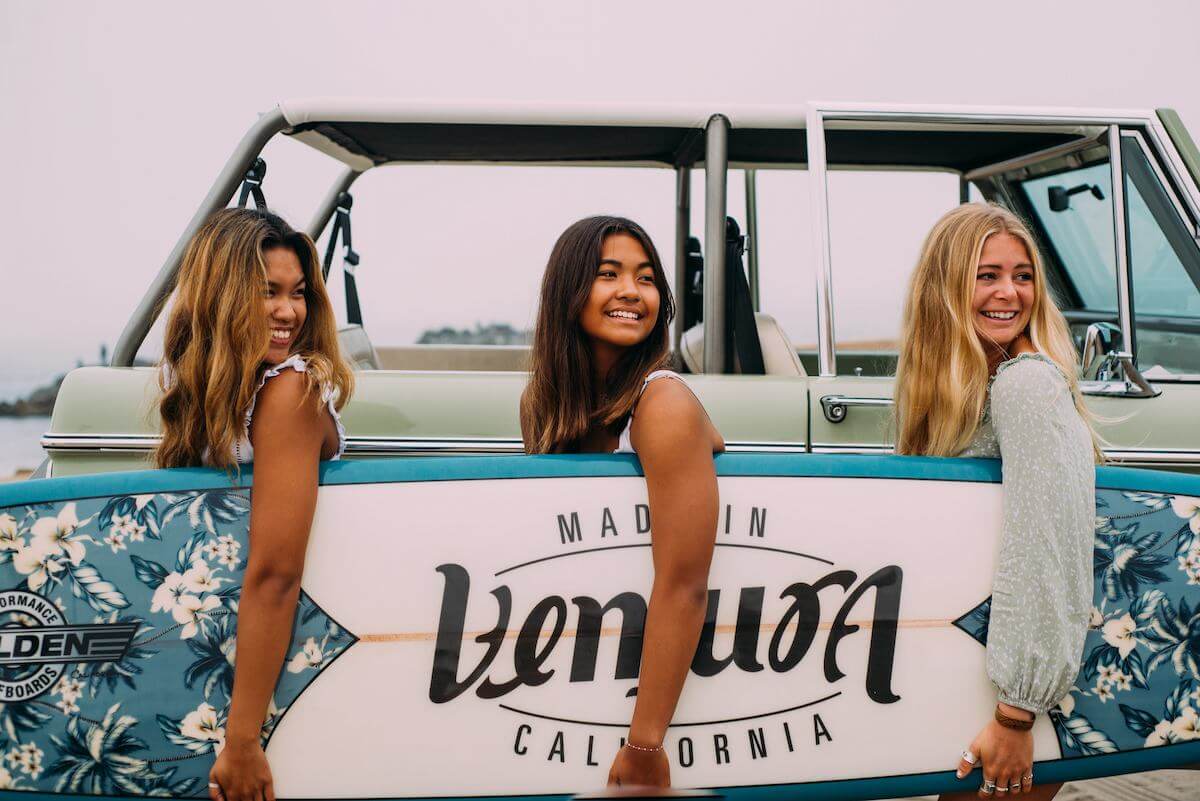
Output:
[0, 489, 356, 797]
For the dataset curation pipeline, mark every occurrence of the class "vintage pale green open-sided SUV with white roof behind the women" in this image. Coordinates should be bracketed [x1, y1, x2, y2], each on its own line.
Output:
[40, 100, 1200, 476]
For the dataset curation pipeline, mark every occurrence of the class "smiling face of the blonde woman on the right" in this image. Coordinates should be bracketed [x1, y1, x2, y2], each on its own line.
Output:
[971, 233, 1036, 351]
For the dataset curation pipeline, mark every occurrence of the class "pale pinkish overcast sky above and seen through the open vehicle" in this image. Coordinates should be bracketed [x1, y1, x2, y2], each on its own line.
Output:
[0, 0, 1200, 399]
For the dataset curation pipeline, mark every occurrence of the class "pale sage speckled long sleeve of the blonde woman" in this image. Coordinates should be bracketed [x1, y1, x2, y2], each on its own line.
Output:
[988, 356, 1096, 713]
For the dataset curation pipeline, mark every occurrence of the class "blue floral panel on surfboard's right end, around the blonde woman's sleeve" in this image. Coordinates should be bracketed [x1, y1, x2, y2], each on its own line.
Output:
[955, 489, 1200, 758]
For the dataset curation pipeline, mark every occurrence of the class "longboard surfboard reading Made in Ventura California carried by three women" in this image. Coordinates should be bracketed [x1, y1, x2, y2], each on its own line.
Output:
[0, 454, 1200, 801]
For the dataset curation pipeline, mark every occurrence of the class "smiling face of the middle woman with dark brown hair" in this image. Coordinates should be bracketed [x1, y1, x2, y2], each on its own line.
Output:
[580, 234, 660, 366]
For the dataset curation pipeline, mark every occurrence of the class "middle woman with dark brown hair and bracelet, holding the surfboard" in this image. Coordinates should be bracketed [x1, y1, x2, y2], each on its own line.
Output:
[521, 217, 725, 787]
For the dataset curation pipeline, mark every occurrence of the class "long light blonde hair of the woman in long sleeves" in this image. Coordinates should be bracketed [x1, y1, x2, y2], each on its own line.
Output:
[895, 203, 1102, 460]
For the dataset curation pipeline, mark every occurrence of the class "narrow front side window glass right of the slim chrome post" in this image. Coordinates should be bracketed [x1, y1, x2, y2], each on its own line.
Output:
[1121, 138, 1200, 378]
